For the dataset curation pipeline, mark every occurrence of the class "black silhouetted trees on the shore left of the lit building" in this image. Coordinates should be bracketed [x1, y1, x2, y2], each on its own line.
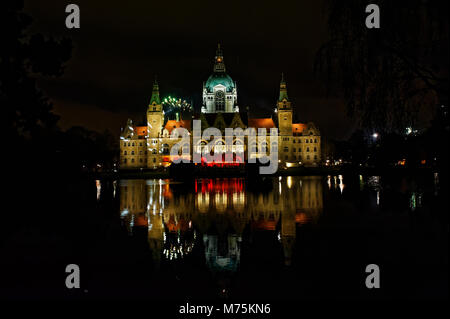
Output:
[0, 0, 118, 178]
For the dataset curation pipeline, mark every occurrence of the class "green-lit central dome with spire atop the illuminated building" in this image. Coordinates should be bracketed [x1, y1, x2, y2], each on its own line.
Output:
[202, 44, 239, 113]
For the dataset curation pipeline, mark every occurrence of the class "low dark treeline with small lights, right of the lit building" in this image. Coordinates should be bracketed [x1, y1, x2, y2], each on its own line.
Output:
[323, 102, 450, 175]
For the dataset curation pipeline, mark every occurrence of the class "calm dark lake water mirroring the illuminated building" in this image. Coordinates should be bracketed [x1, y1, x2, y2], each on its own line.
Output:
[2, 174, 448, 302]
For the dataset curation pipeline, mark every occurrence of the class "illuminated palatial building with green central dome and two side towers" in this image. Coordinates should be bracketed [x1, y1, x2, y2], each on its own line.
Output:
[120, 46, 321, 169]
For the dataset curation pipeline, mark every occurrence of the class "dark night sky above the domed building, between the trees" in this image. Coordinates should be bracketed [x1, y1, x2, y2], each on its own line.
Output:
[25, 0, 353, 138]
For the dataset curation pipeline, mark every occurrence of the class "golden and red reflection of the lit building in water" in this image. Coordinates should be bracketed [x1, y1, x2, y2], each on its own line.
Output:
[119, 176, 323, 272]
